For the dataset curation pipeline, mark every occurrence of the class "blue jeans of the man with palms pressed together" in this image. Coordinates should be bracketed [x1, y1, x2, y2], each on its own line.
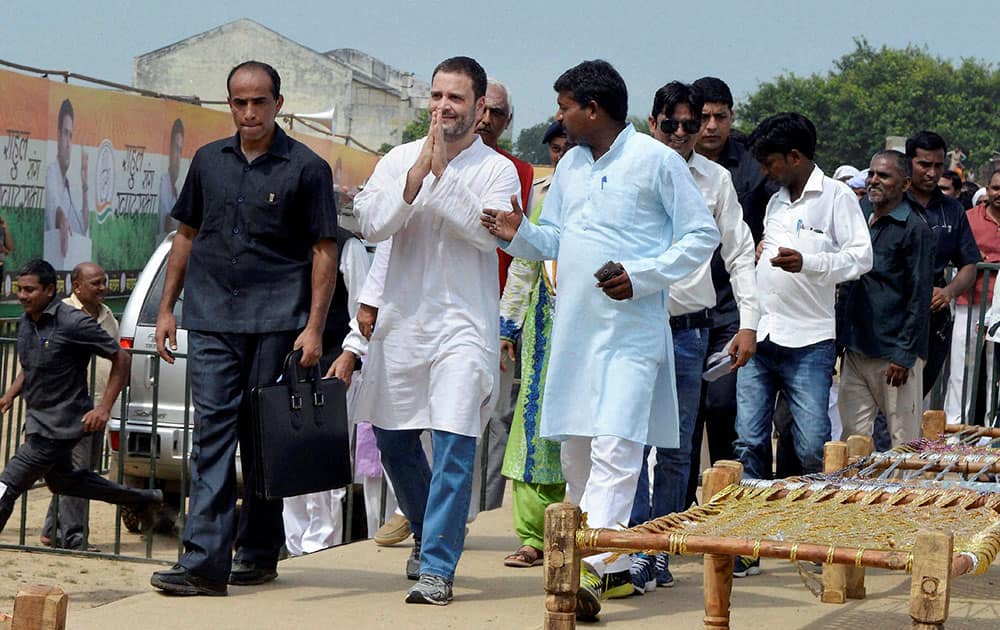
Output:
[375, 427, 476, 580]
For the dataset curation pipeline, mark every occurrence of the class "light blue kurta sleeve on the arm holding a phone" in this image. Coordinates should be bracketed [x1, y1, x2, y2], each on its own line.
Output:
[624, 153, 719, 298]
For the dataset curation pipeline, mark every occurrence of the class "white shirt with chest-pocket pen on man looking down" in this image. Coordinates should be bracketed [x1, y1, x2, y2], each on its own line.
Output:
[757, 166, 873, 348]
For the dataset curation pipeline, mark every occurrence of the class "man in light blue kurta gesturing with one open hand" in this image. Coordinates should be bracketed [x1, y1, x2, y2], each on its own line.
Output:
[483, 61, 719, 618]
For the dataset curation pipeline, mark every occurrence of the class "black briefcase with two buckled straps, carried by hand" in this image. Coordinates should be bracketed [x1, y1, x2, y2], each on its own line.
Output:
[251, 351, 352, 499]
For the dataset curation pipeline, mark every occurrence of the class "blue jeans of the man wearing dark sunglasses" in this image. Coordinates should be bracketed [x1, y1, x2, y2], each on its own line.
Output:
[629, 328, 709, 526]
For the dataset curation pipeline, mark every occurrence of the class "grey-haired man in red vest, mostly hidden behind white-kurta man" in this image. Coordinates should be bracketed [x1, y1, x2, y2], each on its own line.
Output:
[475, 78, 535, 512]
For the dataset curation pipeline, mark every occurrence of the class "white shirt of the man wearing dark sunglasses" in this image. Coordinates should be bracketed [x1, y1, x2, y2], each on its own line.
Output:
[668, 151, 760, 330]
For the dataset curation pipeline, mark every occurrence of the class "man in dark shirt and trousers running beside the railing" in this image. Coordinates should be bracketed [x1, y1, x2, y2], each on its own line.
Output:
[0, 260, 163, 530]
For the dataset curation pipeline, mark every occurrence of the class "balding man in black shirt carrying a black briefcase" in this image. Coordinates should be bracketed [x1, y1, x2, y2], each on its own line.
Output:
[150, 61, 337, 595]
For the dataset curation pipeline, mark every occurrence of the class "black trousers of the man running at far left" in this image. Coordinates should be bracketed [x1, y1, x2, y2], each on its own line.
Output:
[0, 433, 152, 531]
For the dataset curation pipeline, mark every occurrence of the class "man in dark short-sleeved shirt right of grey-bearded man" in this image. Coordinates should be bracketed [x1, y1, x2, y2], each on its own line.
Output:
[906, 131, 982, 396]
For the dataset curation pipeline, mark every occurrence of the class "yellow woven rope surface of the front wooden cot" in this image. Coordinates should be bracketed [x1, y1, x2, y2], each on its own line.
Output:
[620, 475, 1000, 573]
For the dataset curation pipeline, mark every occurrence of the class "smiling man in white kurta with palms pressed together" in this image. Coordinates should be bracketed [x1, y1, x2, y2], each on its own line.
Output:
[354, 58, 520, 604]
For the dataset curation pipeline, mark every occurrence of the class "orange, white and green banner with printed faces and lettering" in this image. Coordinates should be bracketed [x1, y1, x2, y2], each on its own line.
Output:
[0, 71, 377, 299]
